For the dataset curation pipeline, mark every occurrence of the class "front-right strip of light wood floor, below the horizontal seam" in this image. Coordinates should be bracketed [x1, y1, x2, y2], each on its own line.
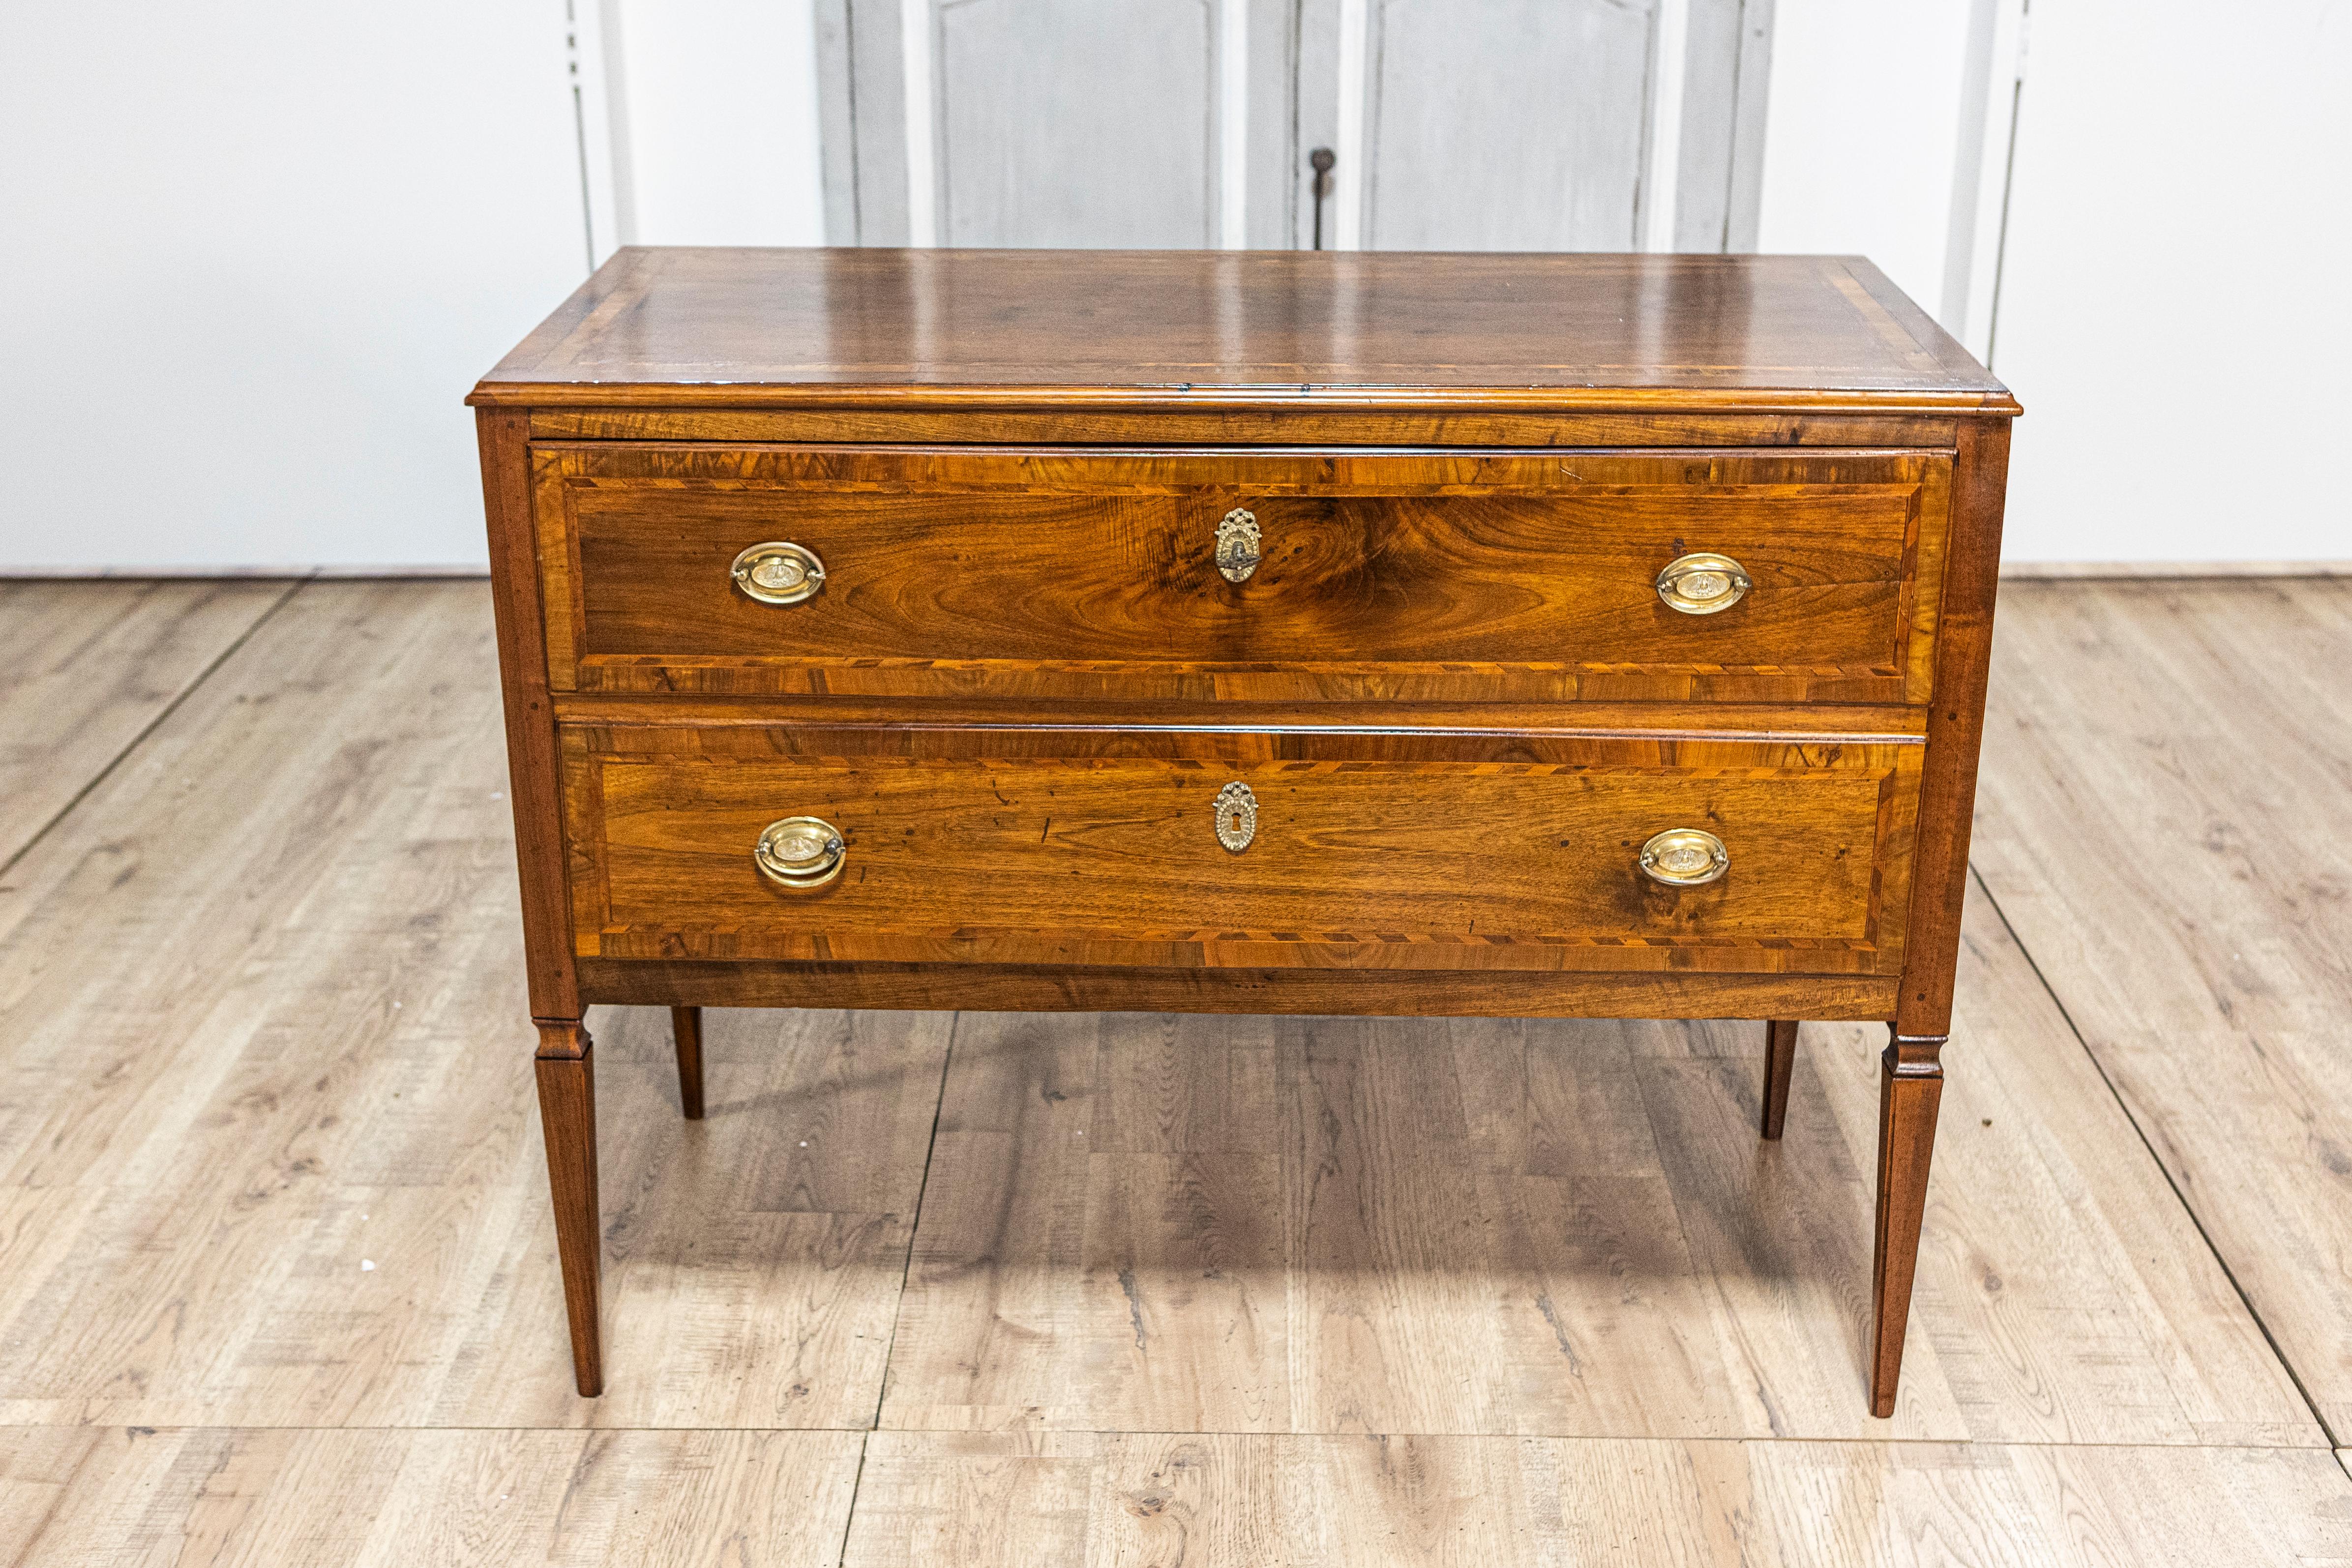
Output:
[842, 1432, 2352, 1568]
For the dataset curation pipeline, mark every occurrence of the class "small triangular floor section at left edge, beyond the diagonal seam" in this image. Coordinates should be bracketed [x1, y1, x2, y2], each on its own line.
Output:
[0, 581, 287, 865]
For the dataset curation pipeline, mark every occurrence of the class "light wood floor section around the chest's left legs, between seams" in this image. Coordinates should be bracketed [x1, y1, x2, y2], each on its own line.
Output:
[0, 583, 950, 1427]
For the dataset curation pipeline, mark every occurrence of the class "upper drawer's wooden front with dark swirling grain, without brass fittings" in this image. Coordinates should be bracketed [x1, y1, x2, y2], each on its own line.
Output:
[534, 444, 1950, 703]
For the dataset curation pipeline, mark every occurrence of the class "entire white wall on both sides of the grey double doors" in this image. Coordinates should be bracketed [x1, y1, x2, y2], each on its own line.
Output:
[0, 0, 2352, 571]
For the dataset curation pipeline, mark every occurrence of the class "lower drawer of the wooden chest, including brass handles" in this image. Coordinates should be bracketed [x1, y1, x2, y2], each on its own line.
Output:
[565, 726, 1922, 976]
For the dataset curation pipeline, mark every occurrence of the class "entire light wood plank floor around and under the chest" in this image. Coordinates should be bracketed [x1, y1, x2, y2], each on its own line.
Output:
[0, 583, 2352, 1568]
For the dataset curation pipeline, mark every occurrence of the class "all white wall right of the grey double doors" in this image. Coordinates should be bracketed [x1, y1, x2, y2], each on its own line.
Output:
[1759, 0, 2352, 564]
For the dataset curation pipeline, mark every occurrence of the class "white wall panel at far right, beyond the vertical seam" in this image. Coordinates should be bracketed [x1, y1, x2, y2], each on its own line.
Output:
[1992, 0, 2352, 562]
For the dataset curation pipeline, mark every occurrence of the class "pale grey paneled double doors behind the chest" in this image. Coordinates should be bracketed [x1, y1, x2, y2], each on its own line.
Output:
[816, 0, 1771, 252]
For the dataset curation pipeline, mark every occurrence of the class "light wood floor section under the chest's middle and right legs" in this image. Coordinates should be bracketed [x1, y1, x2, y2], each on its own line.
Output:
[882, 879, 2326, 1446]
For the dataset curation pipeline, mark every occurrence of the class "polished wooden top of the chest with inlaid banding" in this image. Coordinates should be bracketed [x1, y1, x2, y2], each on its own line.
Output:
[468, 249, 2016, 414]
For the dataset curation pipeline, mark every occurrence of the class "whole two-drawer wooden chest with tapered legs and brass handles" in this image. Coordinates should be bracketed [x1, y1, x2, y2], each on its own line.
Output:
[471, 249, 2016, 1415]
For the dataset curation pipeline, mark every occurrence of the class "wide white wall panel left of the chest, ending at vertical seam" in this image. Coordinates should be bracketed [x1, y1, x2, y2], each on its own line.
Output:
[0, 0, 586, 571]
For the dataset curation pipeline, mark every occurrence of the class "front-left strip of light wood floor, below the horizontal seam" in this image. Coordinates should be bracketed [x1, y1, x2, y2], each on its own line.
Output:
[0, 1427, 859, 1568]
